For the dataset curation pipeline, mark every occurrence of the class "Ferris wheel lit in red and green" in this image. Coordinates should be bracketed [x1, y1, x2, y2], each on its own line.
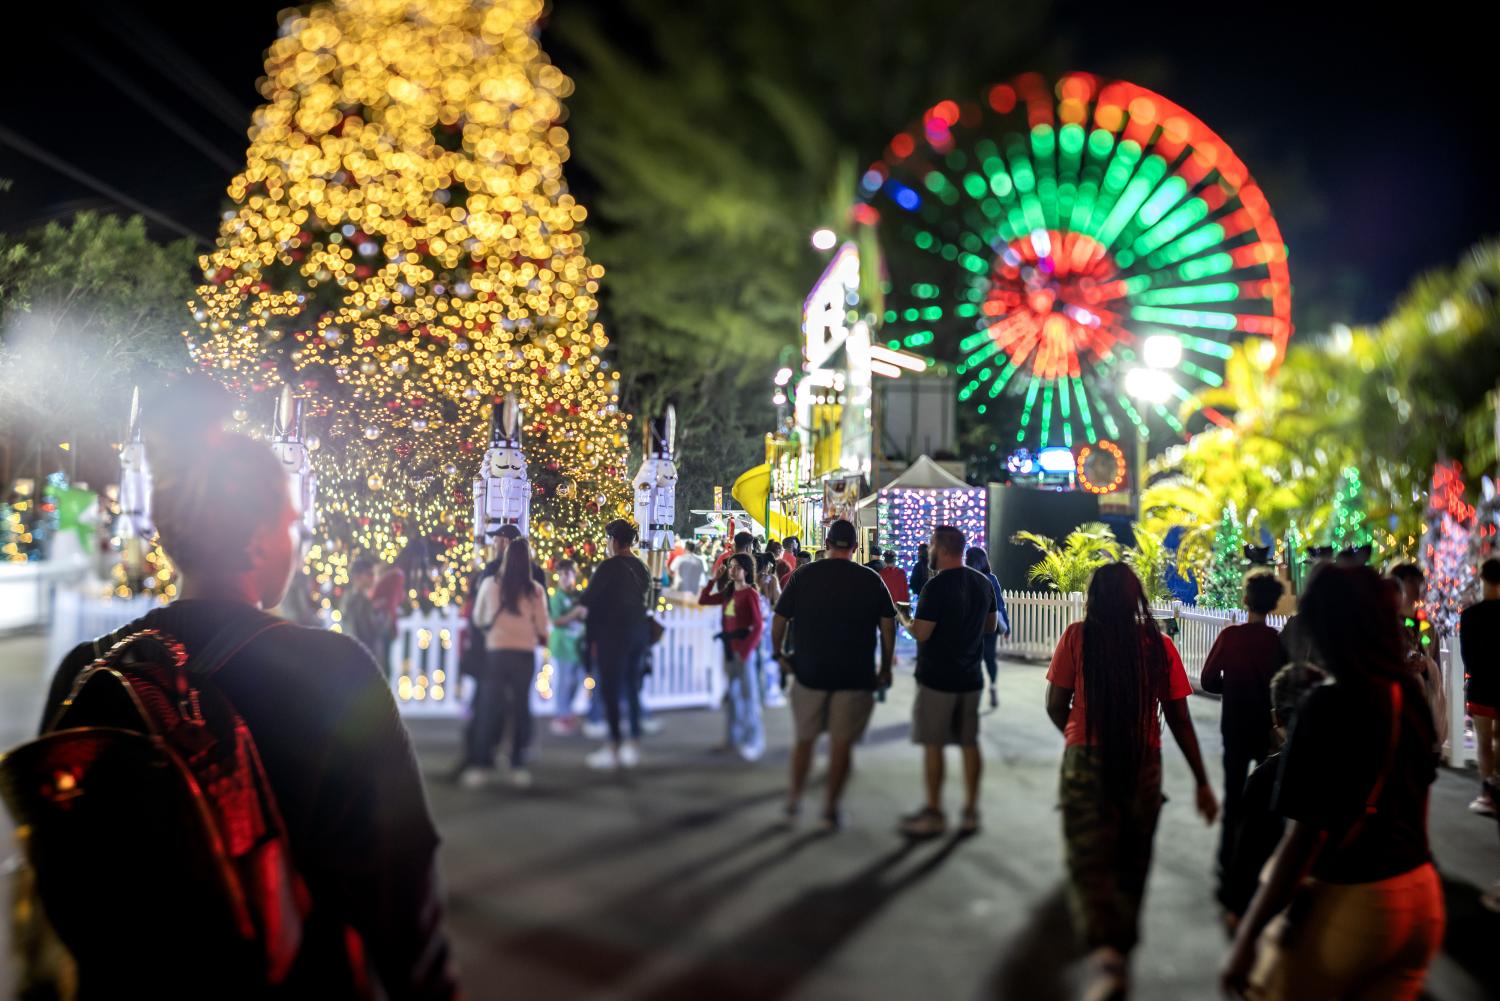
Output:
[861, 74, 1292, 447]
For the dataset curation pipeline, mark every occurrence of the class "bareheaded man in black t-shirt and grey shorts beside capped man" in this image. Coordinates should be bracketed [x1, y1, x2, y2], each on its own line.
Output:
[902, 525, 999, 837]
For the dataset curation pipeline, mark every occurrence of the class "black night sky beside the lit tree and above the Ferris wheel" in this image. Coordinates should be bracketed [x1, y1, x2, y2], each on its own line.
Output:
[0, 0, 1500, 324]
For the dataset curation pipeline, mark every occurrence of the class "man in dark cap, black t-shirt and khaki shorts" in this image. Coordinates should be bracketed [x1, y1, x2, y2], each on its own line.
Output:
[771, 521, 896, 830]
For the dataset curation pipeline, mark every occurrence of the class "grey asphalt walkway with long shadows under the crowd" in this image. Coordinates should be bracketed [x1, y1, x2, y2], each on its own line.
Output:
[0, 636, 1500, 1001]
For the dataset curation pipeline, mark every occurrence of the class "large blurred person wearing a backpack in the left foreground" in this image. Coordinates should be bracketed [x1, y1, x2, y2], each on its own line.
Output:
[11, 381, 458, 999]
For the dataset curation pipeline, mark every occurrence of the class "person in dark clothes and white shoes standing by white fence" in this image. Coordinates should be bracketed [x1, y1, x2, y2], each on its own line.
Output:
[582, 518, 651, 768]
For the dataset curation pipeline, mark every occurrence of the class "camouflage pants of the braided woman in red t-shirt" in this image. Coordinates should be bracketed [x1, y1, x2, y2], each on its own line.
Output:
[1058, 747, 1163, 953]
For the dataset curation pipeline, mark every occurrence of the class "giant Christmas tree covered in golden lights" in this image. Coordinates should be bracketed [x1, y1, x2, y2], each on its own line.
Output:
[189, 0, 629, 602]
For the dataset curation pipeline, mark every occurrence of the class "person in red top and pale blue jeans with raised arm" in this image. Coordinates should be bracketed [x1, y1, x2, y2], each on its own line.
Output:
[698, 552, 765, 761]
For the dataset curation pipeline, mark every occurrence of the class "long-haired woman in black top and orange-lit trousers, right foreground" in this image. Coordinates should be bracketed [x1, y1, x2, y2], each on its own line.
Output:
[1221, 567, 1446, 1001]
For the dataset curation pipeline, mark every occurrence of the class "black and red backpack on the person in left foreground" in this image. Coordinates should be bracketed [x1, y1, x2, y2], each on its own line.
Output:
[0, 620, 309, 995]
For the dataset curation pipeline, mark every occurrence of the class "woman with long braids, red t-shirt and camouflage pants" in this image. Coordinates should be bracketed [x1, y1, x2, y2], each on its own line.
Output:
[1047, 563, 1218, 998]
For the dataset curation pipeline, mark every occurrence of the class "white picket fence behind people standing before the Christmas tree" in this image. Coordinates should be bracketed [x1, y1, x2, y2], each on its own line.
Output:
[390, 603, 725, 716]
